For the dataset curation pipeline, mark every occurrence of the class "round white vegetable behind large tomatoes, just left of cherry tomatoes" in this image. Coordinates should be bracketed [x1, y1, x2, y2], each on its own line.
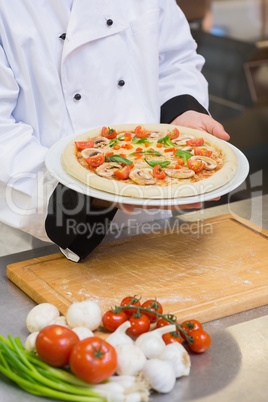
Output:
[66, 300, 102, 331]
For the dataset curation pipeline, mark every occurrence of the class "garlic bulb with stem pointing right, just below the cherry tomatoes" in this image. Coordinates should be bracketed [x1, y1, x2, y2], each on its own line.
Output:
[135, 325, 176, 359]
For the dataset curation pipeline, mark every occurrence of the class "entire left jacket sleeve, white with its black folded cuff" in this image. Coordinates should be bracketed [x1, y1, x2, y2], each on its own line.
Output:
[0, 43, 116, 258]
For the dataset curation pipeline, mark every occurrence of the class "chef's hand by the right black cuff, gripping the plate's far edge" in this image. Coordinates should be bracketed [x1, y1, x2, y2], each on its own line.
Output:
[171, 110, 230, 141]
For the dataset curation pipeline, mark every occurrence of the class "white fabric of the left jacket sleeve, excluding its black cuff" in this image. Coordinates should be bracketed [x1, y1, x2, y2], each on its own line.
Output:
[0, 46, 56, 241]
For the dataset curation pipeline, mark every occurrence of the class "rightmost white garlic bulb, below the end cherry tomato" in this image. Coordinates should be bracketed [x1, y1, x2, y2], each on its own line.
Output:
[158, 342, 191, 378]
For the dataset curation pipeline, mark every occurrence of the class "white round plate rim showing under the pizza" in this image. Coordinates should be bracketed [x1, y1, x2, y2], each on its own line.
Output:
[46, 135, 249, 207]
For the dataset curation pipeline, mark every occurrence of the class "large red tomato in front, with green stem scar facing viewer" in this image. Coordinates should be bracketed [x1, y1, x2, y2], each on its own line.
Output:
[70, 336, 117, 384]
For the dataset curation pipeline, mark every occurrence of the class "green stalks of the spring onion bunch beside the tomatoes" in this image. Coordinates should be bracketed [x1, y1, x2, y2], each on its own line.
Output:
[0, 335, 106, 402]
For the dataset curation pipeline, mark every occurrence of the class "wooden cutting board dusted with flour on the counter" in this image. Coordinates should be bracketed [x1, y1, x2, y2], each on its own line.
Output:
[7, 215, 268, 322]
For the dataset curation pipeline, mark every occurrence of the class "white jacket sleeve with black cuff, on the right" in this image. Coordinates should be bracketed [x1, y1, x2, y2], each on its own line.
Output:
[159, 0, 208, 123]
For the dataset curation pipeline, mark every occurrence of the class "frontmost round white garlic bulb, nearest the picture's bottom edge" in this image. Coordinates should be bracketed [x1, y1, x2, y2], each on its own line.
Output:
[142, 359, 176, 393]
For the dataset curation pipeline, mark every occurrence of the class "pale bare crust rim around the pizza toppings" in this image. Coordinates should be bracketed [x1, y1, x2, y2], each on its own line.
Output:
[62, 124, 238, 199]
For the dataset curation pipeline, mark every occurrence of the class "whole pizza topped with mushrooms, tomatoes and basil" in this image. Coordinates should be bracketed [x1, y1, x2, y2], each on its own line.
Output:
[62, 124, 237, 199]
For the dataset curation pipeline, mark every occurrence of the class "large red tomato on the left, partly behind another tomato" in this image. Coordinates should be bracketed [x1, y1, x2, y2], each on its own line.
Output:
[36, 325, 79, 367]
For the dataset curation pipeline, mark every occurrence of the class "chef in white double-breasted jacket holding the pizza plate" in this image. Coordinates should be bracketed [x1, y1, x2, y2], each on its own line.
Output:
[0, 0, 229, 261]
